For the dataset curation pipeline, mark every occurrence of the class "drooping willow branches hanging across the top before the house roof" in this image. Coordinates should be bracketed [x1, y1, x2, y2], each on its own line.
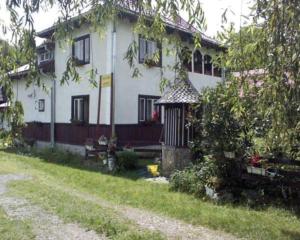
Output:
[2, 0, 206, 86]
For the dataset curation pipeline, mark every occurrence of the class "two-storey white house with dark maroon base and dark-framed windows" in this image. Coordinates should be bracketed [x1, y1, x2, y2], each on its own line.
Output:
[7, 4, 222, 155]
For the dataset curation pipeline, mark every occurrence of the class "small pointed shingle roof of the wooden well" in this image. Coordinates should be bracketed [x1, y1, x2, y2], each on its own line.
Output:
[156, 79, 199, 105]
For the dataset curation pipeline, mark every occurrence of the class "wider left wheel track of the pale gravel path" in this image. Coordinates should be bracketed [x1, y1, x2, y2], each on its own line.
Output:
[0, 174, 106, 240]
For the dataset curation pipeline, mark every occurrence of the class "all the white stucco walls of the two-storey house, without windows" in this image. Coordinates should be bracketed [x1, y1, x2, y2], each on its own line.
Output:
[14, 20, 221, 124]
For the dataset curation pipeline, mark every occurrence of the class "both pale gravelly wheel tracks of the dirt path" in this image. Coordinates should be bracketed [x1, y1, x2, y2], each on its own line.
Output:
[0, 174, 237, 240]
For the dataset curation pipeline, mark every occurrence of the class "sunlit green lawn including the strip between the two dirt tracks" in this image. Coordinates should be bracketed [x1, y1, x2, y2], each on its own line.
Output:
[0, 149, 300, 239]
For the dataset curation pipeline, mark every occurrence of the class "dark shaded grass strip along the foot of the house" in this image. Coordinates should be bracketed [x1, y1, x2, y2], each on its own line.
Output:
[1, 148, 142, 181]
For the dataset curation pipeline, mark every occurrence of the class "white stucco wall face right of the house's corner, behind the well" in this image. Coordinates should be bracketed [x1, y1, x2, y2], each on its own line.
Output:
[115, 20, 221, 124]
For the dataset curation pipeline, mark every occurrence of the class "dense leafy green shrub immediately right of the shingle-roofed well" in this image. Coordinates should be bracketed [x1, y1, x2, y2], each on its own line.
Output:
[191, 84, 243, 156]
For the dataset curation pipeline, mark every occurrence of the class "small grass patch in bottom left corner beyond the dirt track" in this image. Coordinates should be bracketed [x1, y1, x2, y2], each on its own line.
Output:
[0, 208, 34, 240]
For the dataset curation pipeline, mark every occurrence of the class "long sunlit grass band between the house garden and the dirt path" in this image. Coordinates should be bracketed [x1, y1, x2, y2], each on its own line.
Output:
[0, 149, 300, 239]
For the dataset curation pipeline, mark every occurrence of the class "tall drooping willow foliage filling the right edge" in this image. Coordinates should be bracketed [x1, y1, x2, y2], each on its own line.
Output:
[219, 0, 300, 160]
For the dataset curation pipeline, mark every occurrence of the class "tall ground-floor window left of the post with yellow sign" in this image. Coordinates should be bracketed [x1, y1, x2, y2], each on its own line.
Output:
[71, 95, 89, 123]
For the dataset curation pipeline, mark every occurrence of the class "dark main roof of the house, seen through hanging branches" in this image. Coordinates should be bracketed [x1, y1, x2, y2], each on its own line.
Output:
[37, 1, 223, 49]
